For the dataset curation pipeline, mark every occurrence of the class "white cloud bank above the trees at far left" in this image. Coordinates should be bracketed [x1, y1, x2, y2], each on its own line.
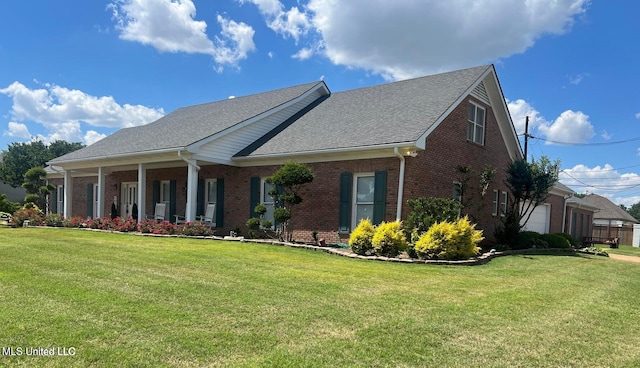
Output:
[0, 82, 164, 143]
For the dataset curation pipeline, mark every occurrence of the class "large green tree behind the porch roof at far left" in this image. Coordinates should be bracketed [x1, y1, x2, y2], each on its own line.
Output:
[0, 140, 84, 188]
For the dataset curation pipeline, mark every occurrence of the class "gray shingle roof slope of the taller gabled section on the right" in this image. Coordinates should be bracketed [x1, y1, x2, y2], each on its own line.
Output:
[240, 65, 492, 157]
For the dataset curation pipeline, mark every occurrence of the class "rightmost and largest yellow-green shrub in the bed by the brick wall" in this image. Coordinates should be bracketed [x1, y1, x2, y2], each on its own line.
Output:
[415, 216, 484, 260]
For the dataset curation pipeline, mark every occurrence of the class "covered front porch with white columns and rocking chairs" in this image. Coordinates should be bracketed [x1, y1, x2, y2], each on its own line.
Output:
[48, 151, 215, 222]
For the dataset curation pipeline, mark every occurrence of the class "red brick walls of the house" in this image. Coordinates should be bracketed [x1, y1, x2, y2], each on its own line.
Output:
[51, 98, 520, 243]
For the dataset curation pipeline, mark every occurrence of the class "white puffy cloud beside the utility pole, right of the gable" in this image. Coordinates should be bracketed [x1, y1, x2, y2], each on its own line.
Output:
[507, 99, 596, 144]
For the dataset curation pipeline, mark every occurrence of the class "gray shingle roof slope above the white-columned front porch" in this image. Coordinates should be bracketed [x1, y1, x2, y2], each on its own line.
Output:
[50, 82, 322, 164]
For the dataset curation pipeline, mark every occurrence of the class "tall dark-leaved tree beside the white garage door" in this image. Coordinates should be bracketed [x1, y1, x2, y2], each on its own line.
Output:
[496, 156, 560, 245]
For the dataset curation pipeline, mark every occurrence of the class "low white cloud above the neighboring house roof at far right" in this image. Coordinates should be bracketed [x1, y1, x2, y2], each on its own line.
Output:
[560, 164, 640, 206]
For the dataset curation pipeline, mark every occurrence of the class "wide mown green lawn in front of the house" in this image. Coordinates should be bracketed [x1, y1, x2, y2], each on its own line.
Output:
[0, 227, 640, 367]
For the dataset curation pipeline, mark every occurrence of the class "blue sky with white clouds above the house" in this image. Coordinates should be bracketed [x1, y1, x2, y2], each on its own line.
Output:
[0, 0, 640, 206]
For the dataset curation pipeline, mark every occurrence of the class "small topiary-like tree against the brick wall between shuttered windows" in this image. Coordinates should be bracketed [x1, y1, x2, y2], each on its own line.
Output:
[266, 161, 313, 241]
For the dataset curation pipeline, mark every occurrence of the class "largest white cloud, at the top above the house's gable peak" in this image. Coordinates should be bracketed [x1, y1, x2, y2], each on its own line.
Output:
[298, 0, 589, 79]
